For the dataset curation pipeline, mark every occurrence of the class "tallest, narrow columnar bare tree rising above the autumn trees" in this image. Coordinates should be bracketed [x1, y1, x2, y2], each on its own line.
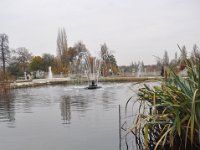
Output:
[57, 28, 68, 63]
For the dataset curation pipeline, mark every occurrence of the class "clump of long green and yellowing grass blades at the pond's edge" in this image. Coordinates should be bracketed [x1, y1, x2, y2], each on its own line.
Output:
[130, 49, 200, 149]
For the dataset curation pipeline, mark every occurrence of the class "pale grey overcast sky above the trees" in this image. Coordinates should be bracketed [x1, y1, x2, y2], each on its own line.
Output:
[0, 0, 200, 65]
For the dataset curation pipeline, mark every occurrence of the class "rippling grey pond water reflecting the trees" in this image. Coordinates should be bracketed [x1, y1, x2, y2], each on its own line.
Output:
[0, 83, 138, 150]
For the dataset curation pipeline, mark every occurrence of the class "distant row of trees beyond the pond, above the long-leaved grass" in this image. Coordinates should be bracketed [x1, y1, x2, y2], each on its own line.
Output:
[119, 44, 200, 75]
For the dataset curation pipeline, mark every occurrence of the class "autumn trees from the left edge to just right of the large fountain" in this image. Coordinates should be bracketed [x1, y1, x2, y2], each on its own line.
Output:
[0, 28, 119, 78]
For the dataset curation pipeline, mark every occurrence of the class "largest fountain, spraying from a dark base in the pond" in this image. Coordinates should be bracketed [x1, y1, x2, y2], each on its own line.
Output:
[80, 52, 102, 89]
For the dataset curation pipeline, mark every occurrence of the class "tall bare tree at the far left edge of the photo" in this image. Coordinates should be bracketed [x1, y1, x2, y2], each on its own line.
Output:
[0, 33, 10, 75]
